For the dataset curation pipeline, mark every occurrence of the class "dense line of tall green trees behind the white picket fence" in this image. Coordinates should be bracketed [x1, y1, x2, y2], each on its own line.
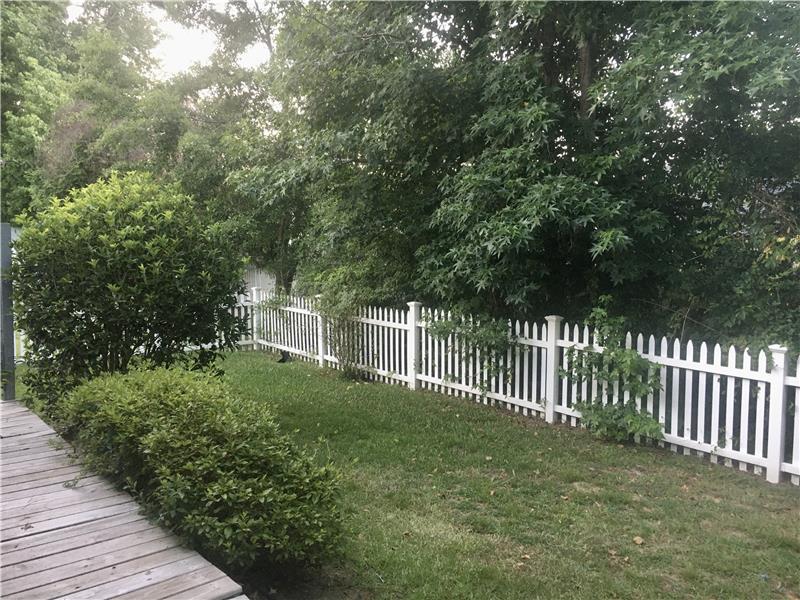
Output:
[2, 0, 800, 347]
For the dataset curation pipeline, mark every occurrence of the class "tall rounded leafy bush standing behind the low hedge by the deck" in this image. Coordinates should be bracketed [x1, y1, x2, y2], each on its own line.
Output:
[13, 173, 245, 408]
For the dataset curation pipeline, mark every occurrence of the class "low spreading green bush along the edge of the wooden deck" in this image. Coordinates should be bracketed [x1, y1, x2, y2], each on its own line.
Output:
[59, 367, 339, 568]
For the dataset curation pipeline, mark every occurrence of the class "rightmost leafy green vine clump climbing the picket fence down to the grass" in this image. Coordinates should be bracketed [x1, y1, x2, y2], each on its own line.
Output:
[561, 296, 663, 442]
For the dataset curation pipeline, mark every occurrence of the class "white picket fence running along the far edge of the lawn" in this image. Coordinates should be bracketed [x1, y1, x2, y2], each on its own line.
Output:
[240, 288, 800, 485]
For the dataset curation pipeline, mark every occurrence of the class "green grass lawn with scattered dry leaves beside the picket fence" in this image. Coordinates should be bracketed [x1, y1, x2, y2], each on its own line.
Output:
[224, 352, 800, 600]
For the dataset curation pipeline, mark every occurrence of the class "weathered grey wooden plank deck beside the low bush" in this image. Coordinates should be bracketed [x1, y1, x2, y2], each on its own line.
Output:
[0, 402, 246, 600]
